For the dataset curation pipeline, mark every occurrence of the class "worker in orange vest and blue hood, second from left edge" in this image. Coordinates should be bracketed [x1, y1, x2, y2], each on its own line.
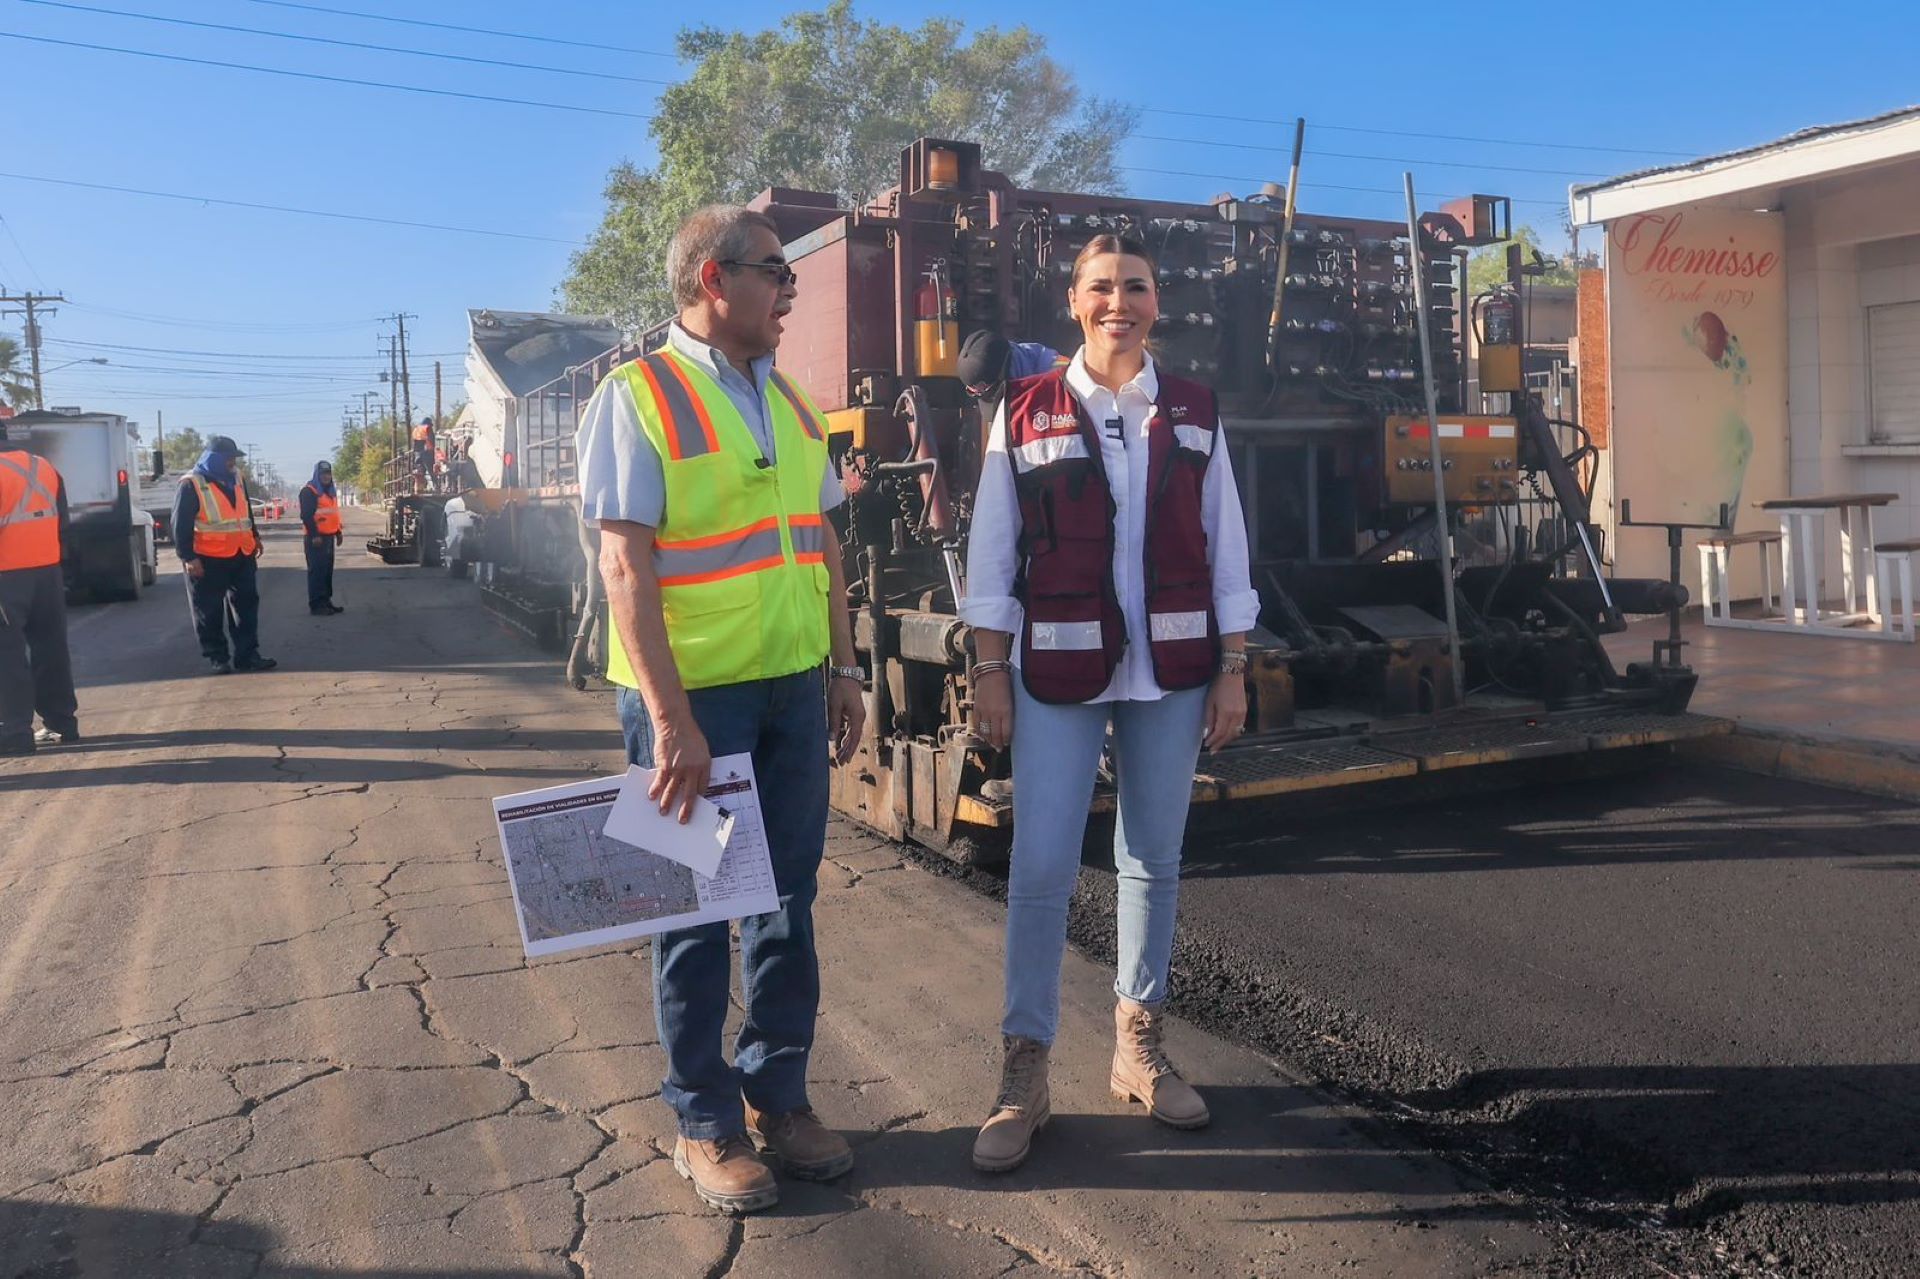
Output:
[173, 436, 280, 674]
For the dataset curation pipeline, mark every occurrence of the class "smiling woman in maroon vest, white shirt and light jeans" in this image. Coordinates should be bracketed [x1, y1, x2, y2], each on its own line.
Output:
[962, 236, 1260, 1171]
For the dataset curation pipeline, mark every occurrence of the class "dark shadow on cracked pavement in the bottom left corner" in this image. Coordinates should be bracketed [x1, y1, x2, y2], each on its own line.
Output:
[0, 1198, 551, 1279]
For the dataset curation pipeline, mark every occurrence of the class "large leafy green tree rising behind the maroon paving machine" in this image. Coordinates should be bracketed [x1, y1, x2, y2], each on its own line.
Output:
[559, 0, 1139, 328]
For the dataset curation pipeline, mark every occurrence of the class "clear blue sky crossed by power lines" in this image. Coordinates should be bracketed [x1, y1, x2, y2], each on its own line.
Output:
[0, 0, 1920, 483]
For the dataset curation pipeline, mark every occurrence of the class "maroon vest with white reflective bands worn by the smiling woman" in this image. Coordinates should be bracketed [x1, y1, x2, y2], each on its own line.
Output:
[1006, 369, 1219, 703]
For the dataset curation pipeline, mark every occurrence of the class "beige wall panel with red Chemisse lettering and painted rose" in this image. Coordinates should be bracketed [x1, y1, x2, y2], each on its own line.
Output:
[1607, 205, 1788, 590]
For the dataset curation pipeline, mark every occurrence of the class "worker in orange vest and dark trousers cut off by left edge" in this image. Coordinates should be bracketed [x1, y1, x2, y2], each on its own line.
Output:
[0, 449, 81, 755]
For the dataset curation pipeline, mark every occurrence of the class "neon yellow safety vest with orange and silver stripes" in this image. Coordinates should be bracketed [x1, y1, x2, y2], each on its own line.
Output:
[595, 351, 829, 688]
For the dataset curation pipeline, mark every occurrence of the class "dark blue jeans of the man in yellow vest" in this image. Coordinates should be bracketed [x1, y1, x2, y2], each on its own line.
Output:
[620, 670, 828, 1141]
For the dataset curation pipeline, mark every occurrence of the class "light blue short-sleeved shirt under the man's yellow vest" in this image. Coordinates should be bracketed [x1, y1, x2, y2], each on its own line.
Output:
[574, 323, 847, 528]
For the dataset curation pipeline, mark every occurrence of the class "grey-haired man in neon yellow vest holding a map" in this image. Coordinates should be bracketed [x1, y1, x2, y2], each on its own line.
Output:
[576, 205, 866, 1212]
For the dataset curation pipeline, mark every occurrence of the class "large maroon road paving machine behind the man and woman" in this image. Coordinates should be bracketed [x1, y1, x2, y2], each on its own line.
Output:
[456, 138, 1724, 860]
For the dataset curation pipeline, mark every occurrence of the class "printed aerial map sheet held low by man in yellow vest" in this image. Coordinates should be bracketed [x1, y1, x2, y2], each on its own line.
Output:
[493, 755, 780, 956]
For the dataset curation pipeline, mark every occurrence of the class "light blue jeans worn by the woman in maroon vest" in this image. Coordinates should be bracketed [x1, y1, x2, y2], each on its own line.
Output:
[1000, 672, 1206, 1043]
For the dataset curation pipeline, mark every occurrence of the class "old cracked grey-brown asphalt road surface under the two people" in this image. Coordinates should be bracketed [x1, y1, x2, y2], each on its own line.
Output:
[0, 511, 1561, 1279]
